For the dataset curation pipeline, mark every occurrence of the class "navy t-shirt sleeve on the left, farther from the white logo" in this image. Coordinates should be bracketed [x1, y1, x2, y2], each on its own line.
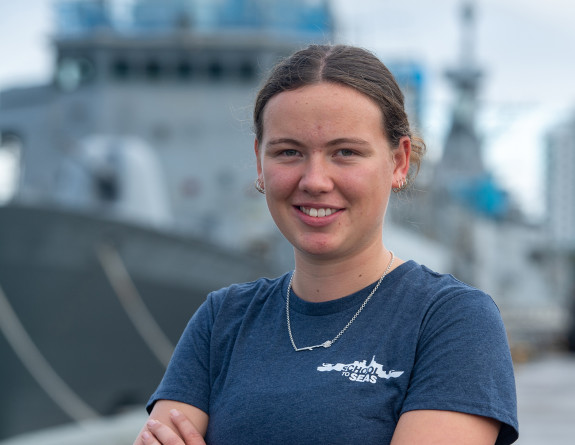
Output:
[146, 295, 214, 413]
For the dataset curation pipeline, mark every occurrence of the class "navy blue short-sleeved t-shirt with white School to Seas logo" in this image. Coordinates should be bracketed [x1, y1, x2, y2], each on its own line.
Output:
[148, 261, 518, 445]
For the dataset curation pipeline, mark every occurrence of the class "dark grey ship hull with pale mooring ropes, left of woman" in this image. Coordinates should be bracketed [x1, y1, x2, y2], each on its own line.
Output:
[0, 205, 276, 438]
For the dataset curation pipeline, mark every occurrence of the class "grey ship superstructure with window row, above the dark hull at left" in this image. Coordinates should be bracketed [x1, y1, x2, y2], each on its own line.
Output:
[0, 0, 332, 248]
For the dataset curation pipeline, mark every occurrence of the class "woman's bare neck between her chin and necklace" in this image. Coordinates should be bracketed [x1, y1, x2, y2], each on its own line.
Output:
[292, 244, 403, 302]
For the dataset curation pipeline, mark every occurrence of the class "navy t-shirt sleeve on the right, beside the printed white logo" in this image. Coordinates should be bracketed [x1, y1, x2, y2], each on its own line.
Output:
[402, 290, 518, 444]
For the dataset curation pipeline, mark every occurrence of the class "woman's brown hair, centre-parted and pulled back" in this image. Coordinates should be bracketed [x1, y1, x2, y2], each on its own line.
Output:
[254, 45, 425, 182]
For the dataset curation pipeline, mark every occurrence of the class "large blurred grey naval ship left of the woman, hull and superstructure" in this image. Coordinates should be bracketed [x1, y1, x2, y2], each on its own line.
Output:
[0, 0, 333, 439]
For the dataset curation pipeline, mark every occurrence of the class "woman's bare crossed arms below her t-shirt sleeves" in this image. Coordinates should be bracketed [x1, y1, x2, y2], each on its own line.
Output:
[134, 400, 501, 445]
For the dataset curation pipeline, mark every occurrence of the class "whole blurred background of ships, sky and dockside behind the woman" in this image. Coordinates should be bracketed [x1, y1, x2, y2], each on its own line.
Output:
[0, 0, 575, 445]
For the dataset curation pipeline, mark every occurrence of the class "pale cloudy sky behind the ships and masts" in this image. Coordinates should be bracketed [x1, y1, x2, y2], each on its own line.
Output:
[0, 0, 575, 217]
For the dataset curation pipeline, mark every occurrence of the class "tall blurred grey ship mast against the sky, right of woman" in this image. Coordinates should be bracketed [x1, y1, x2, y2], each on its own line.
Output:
[427, 0, 488, 284]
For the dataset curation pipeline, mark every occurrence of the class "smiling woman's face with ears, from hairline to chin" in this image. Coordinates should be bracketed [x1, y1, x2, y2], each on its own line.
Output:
[255, 83, 411, 259]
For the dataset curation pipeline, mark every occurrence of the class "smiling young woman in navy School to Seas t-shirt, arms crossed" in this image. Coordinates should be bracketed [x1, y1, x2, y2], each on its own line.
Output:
[135, 45, 517, 445]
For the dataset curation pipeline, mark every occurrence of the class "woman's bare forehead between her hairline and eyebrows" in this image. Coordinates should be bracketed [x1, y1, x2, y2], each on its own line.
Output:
[262, 82, 383, 133]
